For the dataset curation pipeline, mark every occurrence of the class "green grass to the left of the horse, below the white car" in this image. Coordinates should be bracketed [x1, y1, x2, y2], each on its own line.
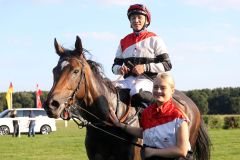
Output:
[0, 121, 87, 160]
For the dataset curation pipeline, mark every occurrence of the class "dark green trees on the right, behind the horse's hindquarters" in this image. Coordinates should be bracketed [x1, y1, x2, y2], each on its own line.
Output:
[185, 87, 240, 114]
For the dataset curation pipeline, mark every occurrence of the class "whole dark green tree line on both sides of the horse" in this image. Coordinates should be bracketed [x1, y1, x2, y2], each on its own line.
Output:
[0, 87, 240, 115]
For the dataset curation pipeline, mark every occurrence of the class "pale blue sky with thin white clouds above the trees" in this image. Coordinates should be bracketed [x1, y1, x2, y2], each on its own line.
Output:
[0, 0, 240, 92]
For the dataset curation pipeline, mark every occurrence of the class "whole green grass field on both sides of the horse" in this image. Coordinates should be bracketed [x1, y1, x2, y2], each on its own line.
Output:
[0, 121, 240, 160]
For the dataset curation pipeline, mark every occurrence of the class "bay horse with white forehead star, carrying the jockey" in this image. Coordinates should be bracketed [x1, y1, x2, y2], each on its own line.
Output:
[44, 36, 210, 160]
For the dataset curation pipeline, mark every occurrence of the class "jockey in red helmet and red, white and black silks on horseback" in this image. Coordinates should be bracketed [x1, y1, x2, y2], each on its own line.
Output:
[112, 4, 172, 107]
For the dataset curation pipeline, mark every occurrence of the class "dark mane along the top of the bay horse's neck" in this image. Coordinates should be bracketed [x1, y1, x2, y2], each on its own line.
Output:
[87, 60, 116, 92]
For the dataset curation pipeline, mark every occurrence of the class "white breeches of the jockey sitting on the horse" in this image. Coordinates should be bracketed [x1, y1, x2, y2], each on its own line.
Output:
[116, 76, 153, 96]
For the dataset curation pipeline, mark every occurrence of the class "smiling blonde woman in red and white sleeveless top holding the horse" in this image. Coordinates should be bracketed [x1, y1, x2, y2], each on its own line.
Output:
[110, 73, 192, 160]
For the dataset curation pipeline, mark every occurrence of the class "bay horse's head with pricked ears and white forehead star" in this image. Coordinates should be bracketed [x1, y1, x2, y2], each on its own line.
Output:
[44, 36, 87, 118]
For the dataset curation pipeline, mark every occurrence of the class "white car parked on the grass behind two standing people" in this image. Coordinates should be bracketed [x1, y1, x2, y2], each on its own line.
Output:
[0, 108, 57, 135]
